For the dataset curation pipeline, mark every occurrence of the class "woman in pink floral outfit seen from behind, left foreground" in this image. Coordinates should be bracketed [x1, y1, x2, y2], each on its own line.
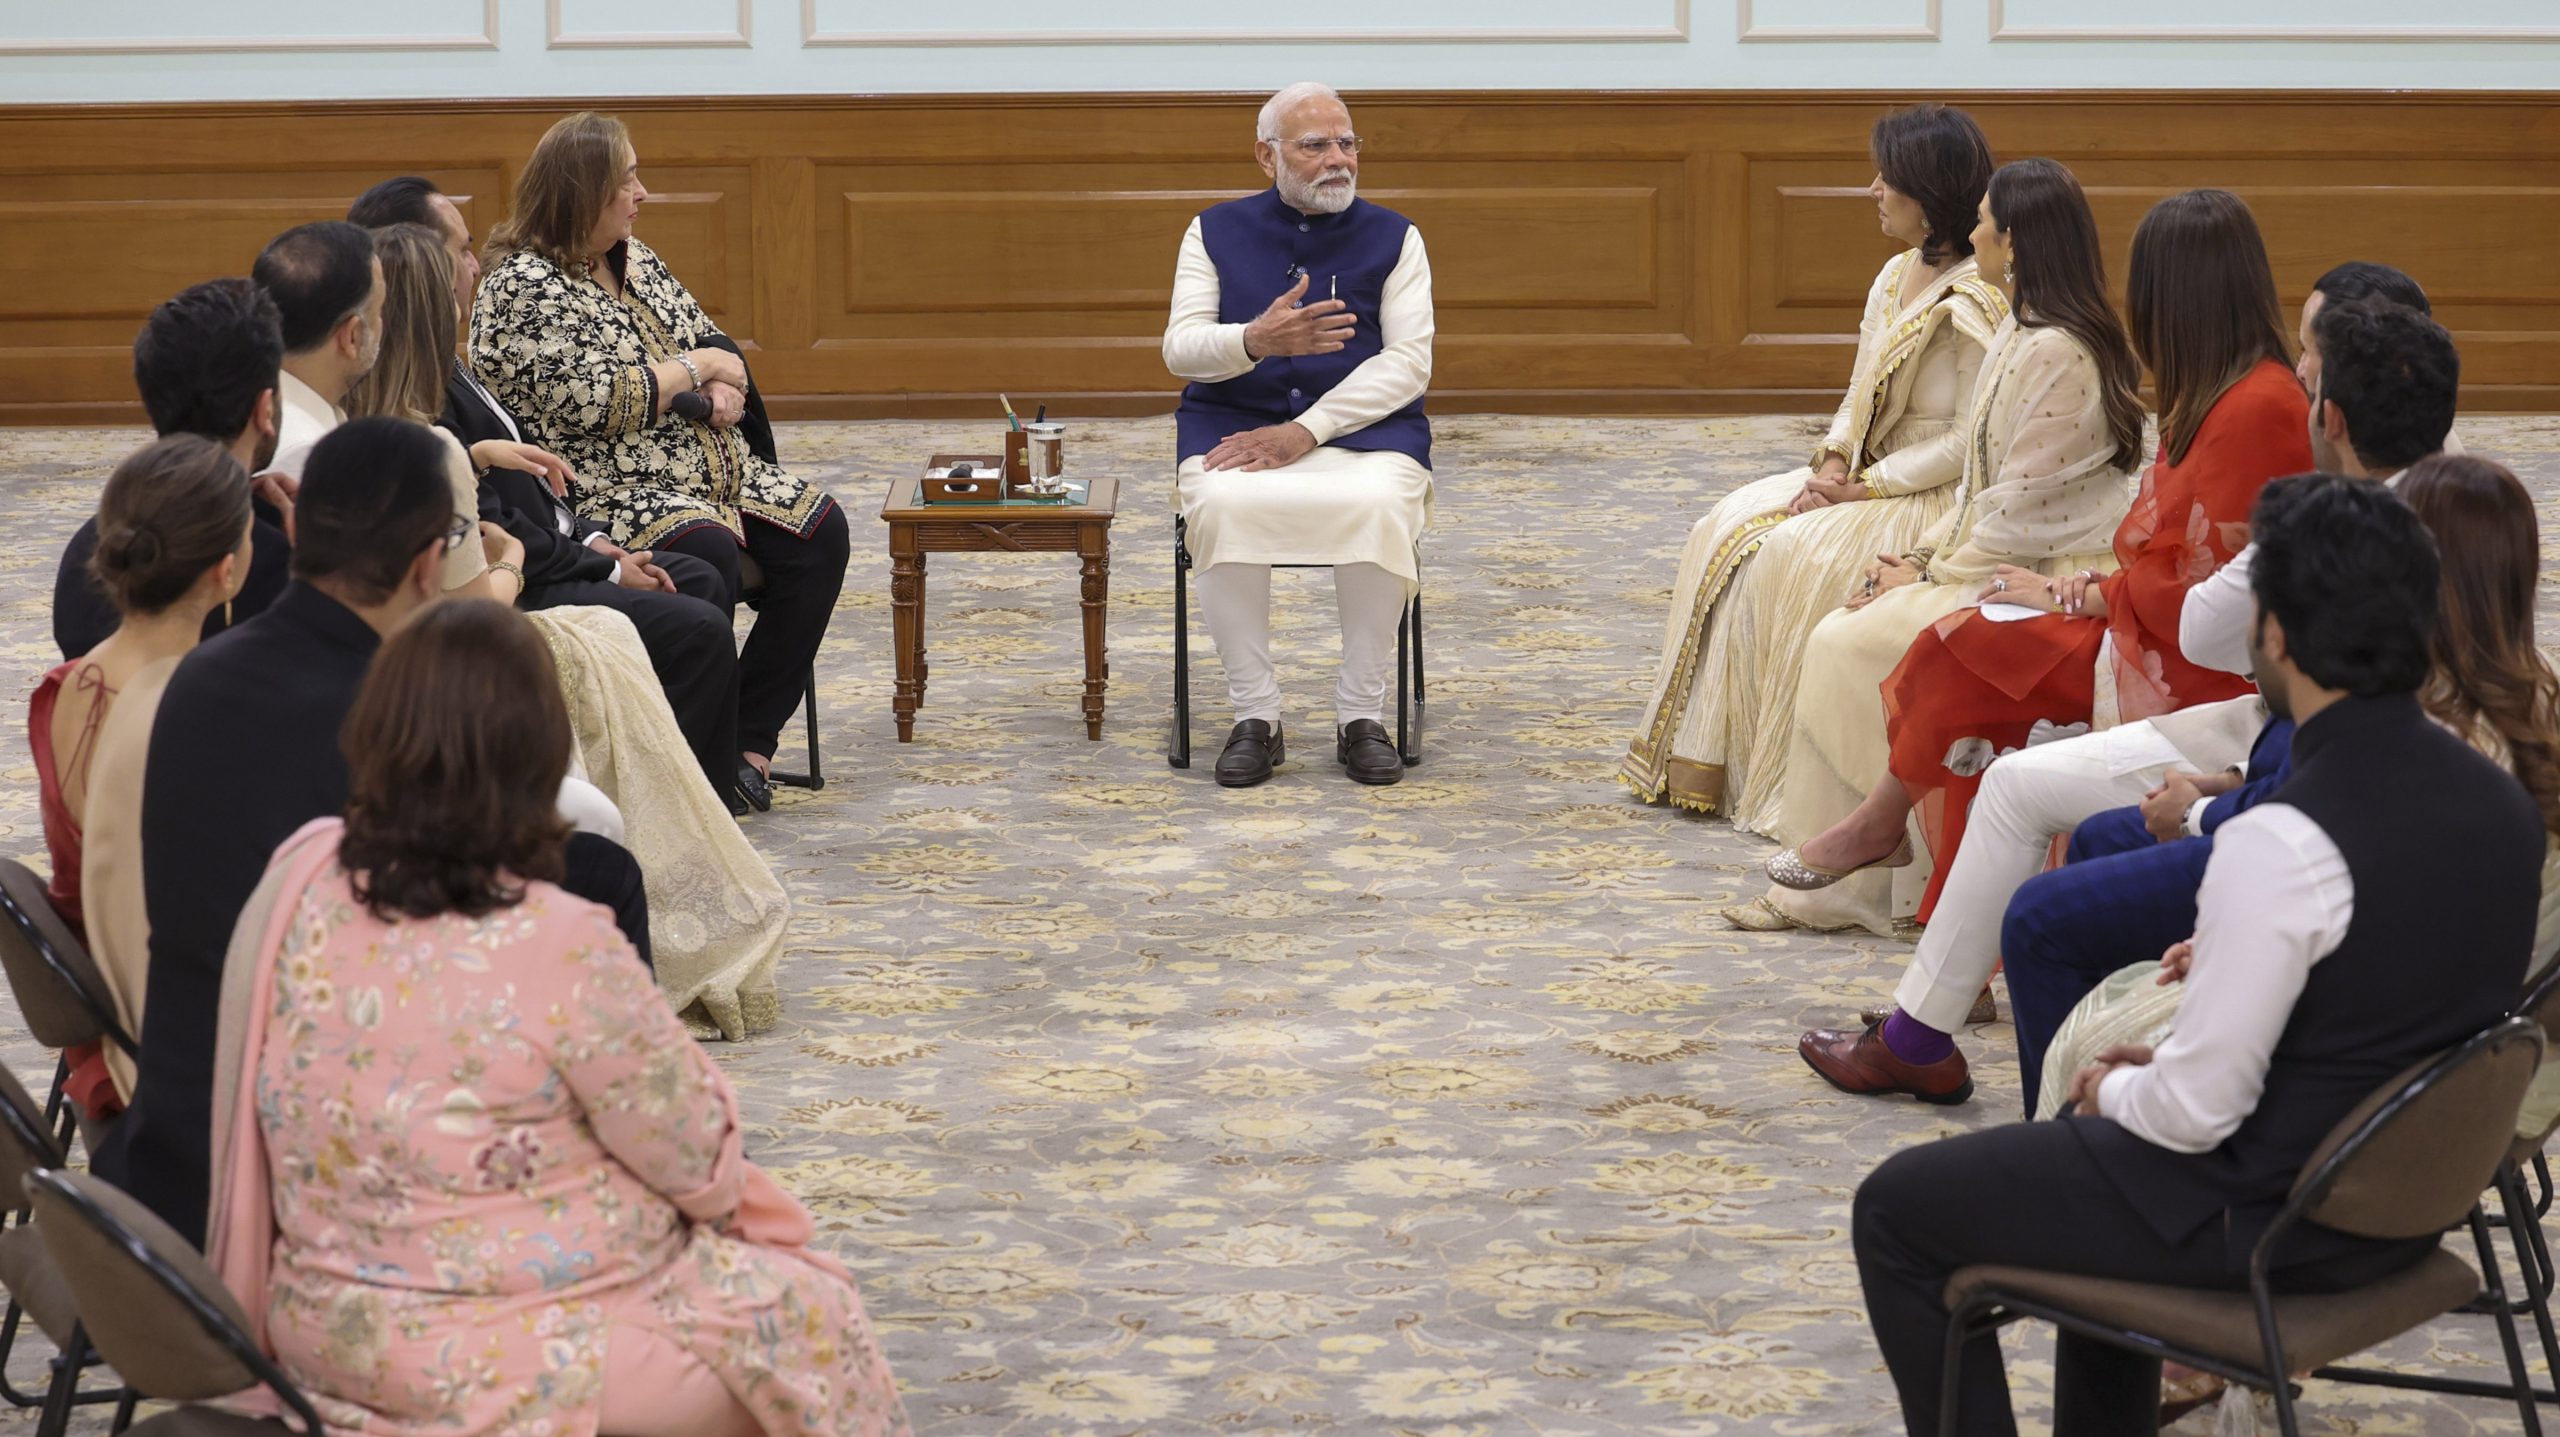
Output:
[207, 602, 909, 1437]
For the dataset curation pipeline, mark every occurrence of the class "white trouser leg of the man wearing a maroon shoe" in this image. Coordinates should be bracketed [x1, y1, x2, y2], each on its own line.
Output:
[1894, 722, 2186, 1032]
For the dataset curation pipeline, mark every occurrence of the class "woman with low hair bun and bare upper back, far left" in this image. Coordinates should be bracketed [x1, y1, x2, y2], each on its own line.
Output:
[26, 433, 251, 1119]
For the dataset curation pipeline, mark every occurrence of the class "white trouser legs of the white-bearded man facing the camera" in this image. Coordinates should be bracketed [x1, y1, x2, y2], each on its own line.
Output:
[1198, 564, 1405, 725]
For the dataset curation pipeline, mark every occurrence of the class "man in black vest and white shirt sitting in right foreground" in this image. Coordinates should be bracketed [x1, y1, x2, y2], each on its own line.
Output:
[1851, 474, 2542, 1437]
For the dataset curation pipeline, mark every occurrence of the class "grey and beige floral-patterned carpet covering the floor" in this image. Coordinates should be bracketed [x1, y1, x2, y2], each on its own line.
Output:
[0, 415, 2560, 1437]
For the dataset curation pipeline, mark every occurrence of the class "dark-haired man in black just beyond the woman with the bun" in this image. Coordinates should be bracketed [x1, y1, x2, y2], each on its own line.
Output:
[54, 279, 294, 658]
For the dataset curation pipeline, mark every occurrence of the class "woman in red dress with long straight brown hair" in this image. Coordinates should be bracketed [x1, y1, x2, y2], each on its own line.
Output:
[1769, 190, 2314, 922]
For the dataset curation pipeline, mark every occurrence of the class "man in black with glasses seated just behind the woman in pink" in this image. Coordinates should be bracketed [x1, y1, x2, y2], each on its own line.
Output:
[97, 418, 648, 1242]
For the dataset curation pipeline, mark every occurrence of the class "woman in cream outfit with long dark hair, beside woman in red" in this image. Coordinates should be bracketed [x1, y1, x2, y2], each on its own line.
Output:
[1725, 159, 2143, 935]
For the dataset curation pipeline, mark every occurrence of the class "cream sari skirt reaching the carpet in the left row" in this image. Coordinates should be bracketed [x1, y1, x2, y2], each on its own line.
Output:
[525, 605, 791, 1040]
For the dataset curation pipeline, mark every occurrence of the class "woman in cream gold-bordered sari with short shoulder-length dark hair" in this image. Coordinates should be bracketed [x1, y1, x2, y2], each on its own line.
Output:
[1618, 105, 2010, 827]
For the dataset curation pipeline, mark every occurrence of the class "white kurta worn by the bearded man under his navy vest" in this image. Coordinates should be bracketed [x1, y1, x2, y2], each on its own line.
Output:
[1165, 220, 1434, 589]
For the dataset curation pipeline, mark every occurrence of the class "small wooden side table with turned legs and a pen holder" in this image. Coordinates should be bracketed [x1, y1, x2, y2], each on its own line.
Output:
[881, 453, 1119, 743]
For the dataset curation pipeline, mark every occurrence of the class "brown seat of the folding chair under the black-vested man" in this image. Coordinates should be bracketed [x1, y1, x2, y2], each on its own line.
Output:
[1946, 1247, 2481, 1373]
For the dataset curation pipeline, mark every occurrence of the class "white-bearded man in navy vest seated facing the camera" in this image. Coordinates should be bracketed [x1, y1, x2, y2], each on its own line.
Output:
[1165, 82, 1434, 789]
